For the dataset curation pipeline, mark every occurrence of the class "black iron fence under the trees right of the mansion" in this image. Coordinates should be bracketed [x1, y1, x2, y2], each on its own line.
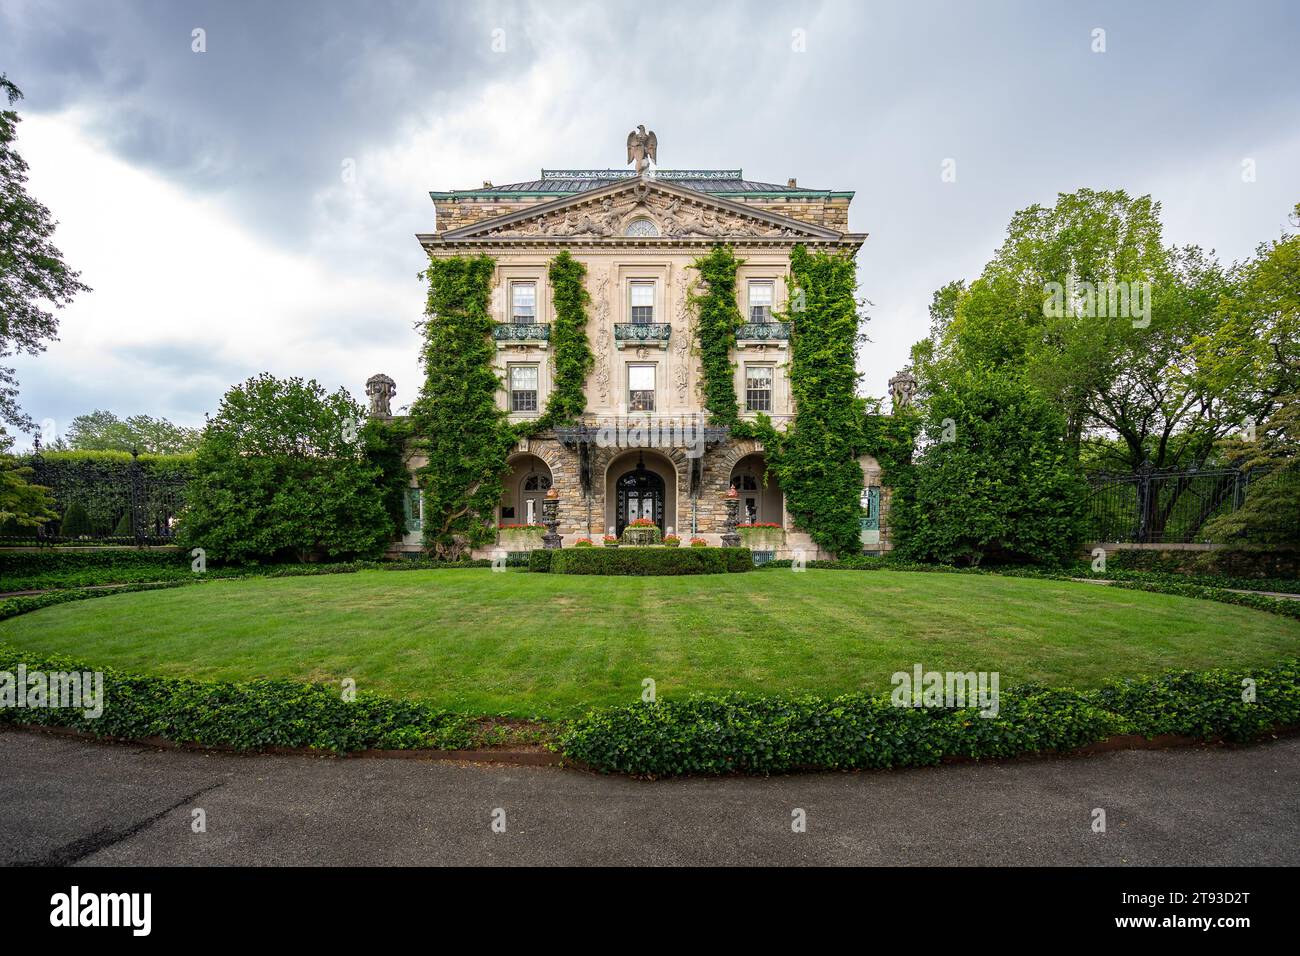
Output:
[1087, 468, 1256, 544]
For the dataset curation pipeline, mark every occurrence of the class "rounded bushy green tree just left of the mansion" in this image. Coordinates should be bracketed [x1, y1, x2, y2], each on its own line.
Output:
[181, 373, 393, 562]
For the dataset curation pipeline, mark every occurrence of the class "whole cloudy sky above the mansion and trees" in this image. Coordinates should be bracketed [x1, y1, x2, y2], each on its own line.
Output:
[0, 0, 1300, 444]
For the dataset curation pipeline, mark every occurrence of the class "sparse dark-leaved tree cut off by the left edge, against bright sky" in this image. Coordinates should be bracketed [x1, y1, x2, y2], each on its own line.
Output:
[0, 74, 90, 431]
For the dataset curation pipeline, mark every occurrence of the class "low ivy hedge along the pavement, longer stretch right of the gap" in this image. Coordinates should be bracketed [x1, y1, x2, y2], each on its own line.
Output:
[560, 661, 1300, 777]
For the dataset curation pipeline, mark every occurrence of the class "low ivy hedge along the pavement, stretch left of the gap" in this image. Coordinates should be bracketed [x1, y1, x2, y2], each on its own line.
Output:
[0, 644, 473, 753]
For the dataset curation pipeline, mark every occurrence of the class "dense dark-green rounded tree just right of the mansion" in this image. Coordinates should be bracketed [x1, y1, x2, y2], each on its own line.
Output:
[891, 371, 1086, 564]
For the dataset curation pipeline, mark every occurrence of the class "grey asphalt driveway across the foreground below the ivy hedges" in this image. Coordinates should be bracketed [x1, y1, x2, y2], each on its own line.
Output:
[0, 730, 1300, 866]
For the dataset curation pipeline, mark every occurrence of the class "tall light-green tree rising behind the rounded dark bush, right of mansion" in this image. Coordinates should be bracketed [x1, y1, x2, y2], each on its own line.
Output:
[914, 189, 1242, 471]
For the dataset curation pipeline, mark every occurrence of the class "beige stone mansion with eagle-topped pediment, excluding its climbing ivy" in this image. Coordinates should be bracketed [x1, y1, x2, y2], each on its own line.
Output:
[367, 138, 888, 558]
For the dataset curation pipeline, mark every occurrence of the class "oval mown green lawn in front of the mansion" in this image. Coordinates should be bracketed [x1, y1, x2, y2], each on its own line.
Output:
[0, 570, 1300, 717]
